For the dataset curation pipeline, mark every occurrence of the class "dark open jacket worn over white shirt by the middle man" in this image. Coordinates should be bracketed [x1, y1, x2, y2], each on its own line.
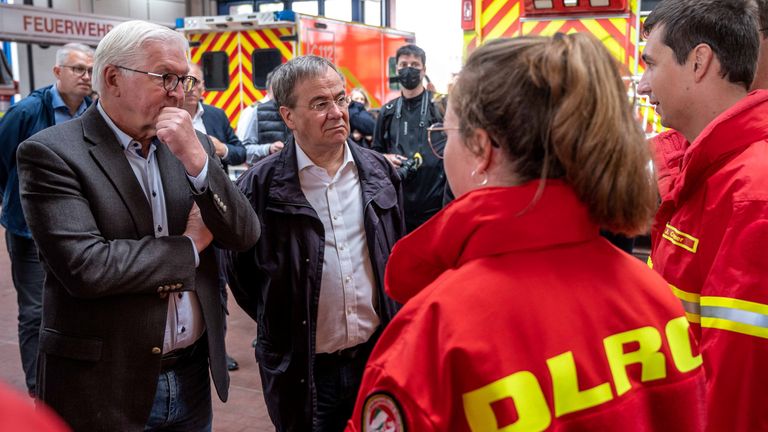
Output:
[228, 138, 404, 432]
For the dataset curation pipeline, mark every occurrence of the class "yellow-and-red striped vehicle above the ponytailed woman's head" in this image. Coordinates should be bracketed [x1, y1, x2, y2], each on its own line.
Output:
[461, 0, 662, 136]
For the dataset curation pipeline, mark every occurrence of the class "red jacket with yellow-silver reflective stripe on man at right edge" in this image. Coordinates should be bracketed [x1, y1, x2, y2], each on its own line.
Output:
[651, 91, 768, 431]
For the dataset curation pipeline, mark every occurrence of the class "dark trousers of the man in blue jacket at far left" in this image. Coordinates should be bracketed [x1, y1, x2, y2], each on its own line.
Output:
[5, 231, 45, 394]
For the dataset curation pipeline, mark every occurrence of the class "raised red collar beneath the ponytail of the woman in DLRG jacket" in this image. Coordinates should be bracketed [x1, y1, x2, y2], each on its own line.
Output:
[385, 180, 599, 303]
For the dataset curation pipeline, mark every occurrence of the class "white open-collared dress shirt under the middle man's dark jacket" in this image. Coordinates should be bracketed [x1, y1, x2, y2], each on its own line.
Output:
[296, 144, 380, 353]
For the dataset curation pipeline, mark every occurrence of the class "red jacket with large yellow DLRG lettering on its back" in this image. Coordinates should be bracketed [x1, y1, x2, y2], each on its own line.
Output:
[347, 181, 704, 432]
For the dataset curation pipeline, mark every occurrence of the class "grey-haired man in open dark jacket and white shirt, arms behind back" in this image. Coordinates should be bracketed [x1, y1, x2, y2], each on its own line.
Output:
[229, 56, 404, 432]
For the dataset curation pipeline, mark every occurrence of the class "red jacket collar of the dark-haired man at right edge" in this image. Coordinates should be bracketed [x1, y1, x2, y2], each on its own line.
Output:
[672, 90, 768, 199]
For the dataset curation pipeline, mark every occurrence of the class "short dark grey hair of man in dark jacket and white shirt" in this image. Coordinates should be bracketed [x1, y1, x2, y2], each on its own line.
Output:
[272, 56, 344, 108]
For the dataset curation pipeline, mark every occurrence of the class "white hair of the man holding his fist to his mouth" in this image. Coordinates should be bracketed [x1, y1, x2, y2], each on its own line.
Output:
[91, 21, 189, 93]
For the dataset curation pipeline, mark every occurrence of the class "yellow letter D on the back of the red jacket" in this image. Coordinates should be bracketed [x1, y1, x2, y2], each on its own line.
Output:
[462, 371, 552, 432]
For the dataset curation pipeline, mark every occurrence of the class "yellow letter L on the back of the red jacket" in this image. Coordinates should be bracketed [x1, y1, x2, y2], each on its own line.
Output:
[547, 351, 613, 417]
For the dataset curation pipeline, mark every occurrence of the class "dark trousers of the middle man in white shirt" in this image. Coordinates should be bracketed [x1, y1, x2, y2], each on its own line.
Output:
[312, 332, 380, 432]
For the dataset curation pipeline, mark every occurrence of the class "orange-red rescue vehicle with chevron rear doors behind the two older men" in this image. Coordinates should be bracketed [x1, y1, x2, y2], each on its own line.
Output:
[181, 11, 415, 127]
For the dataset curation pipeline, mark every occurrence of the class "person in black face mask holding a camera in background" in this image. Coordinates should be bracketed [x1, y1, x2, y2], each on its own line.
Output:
[372, 44, 446, 232]
